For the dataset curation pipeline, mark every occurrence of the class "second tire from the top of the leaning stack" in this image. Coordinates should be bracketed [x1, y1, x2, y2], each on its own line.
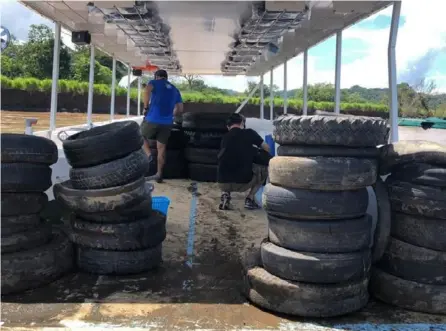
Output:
[70, 149, 149, 190]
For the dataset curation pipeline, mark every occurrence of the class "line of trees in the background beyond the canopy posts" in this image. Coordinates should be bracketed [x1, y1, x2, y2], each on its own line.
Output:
[1, 24, 446, 117]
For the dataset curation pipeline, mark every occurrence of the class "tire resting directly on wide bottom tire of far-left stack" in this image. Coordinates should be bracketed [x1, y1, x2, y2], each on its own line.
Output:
[1, 226, 51, 254]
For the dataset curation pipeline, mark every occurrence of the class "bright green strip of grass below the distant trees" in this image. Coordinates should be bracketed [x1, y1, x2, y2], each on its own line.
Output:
[0, 76, 389, 112]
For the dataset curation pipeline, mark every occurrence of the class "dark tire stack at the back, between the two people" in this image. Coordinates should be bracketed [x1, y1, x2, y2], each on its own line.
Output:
[182, 112, 229, 182]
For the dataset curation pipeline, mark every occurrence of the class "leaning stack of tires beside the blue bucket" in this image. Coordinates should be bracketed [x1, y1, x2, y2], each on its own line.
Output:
[54, 121, 166, 275]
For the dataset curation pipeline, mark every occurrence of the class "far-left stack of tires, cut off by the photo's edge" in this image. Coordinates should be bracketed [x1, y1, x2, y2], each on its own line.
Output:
[1, 134, 73, 295]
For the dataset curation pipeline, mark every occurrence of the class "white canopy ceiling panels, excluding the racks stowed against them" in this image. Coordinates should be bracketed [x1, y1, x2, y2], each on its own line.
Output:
[21, 0, 392, 76]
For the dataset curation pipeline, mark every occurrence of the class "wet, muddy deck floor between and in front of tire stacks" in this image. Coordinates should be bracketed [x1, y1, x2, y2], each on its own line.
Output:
[1, 181, 446, 331]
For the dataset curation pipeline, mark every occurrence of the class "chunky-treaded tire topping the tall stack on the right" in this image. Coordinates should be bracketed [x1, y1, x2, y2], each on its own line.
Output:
[273, 115, 390, 147]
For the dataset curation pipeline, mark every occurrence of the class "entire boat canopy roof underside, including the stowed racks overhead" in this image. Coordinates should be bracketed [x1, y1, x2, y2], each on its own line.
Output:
[20, 0, 392, 76]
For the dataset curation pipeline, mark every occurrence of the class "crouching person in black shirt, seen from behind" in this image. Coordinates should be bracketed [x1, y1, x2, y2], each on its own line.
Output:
[218, 113, 271, 210]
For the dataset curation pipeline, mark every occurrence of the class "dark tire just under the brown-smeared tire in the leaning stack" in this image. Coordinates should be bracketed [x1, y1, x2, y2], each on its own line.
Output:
[76, 195, 152, 224]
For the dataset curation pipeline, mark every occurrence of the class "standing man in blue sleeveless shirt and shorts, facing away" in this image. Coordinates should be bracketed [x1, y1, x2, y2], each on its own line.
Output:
[141, 70, 183, 183]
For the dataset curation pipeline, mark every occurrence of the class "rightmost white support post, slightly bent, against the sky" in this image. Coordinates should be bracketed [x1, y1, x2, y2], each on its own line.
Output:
[388, 1, 401, 143]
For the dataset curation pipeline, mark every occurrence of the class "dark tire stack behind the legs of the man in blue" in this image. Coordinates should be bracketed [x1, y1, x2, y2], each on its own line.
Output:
[146, 126, 189, 179]
